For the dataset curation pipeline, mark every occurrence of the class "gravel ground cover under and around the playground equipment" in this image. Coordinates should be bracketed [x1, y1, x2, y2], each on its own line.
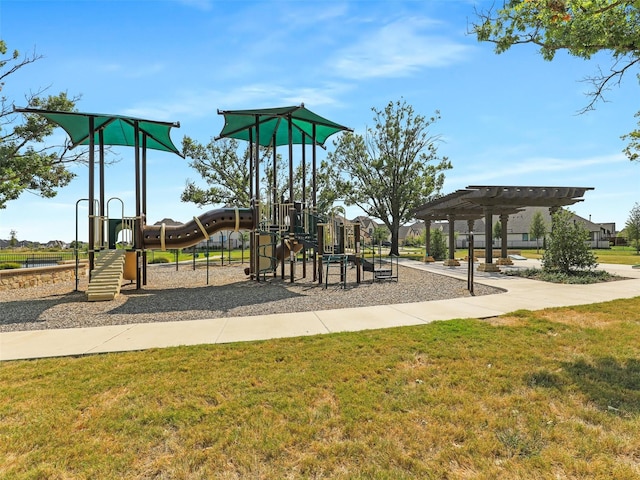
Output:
[0, 264, 501, 332]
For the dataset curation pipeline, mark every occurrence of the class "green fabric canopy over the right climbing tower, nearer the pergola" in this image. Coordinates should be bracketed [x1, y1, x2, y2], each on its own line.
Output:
[216, 104, 351, 147]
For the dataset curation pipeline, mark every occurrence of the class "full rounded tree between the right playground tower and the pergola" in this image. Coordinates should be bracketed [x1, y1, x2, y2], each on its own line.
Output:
[321, 100, 451, 255]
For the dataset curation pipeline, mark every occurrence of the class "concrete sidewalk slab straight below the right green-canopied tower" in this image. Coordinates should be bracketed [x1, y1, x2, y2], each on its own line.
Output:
[216, 312, 328, 343]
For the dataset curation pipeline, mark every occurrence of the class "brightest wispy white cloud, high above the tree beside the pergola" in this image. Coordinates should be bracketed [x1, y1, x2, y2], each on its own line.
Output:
[329, 18, 470, 79]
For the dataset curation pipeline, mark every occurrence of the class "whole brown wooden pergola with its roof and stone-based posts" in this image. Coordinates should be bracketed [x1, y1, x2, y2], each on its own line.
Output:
[415, 185, 593, 271]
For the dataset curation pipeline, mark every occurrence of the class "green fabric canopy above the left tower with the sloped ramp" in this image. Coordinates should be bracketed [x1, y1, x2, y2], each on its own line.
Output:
[16, 108, 182, 156]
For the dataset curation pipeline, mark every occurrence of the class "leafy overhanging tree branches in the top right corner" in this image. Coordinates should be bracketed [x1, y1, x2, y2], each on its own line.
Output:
[471, 0, 640, 160]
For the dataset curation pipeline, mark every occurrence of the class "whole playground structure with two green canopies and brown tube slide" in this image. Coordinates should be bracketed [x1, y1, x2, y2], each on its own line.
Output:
[16, 105, 397, 300]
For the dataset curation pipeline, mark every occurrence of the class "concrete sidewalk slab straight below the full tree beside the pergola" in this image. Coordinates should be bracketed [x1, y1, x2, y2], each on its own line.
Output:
[316, 305, 424, 332]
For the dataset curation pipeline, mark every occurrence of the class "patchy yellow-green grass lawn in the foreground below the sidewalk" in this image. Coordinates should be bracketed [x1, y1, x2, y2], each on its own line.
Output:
[0, 297, 640, 480]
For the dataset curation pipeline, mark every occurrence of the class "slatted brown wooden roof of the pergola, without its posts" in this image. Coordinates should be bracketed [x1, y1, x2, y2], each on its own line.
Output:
[414, 185, 593, 220]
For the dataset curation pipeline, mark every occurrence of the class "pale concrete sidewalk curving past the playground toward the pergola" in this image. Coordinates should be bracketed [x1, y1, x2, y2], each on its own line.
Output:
[0, 260, 640, 361]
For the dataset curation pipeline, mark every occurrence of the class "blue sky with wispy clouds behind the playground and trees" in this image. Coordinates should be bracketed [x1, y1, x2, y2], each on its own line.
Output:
[0, 0, 640, 242]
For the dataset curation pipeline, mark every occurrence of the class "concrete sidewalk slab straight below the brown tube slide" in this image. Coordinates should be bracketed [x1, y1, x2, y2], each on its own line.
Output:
[90, 318, 227, 353]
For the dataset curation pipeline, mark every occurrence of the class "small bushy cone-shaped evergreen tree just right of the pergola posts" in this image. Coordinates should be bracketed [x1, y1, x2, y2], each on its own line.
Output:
[542, 209, 598, 275]
